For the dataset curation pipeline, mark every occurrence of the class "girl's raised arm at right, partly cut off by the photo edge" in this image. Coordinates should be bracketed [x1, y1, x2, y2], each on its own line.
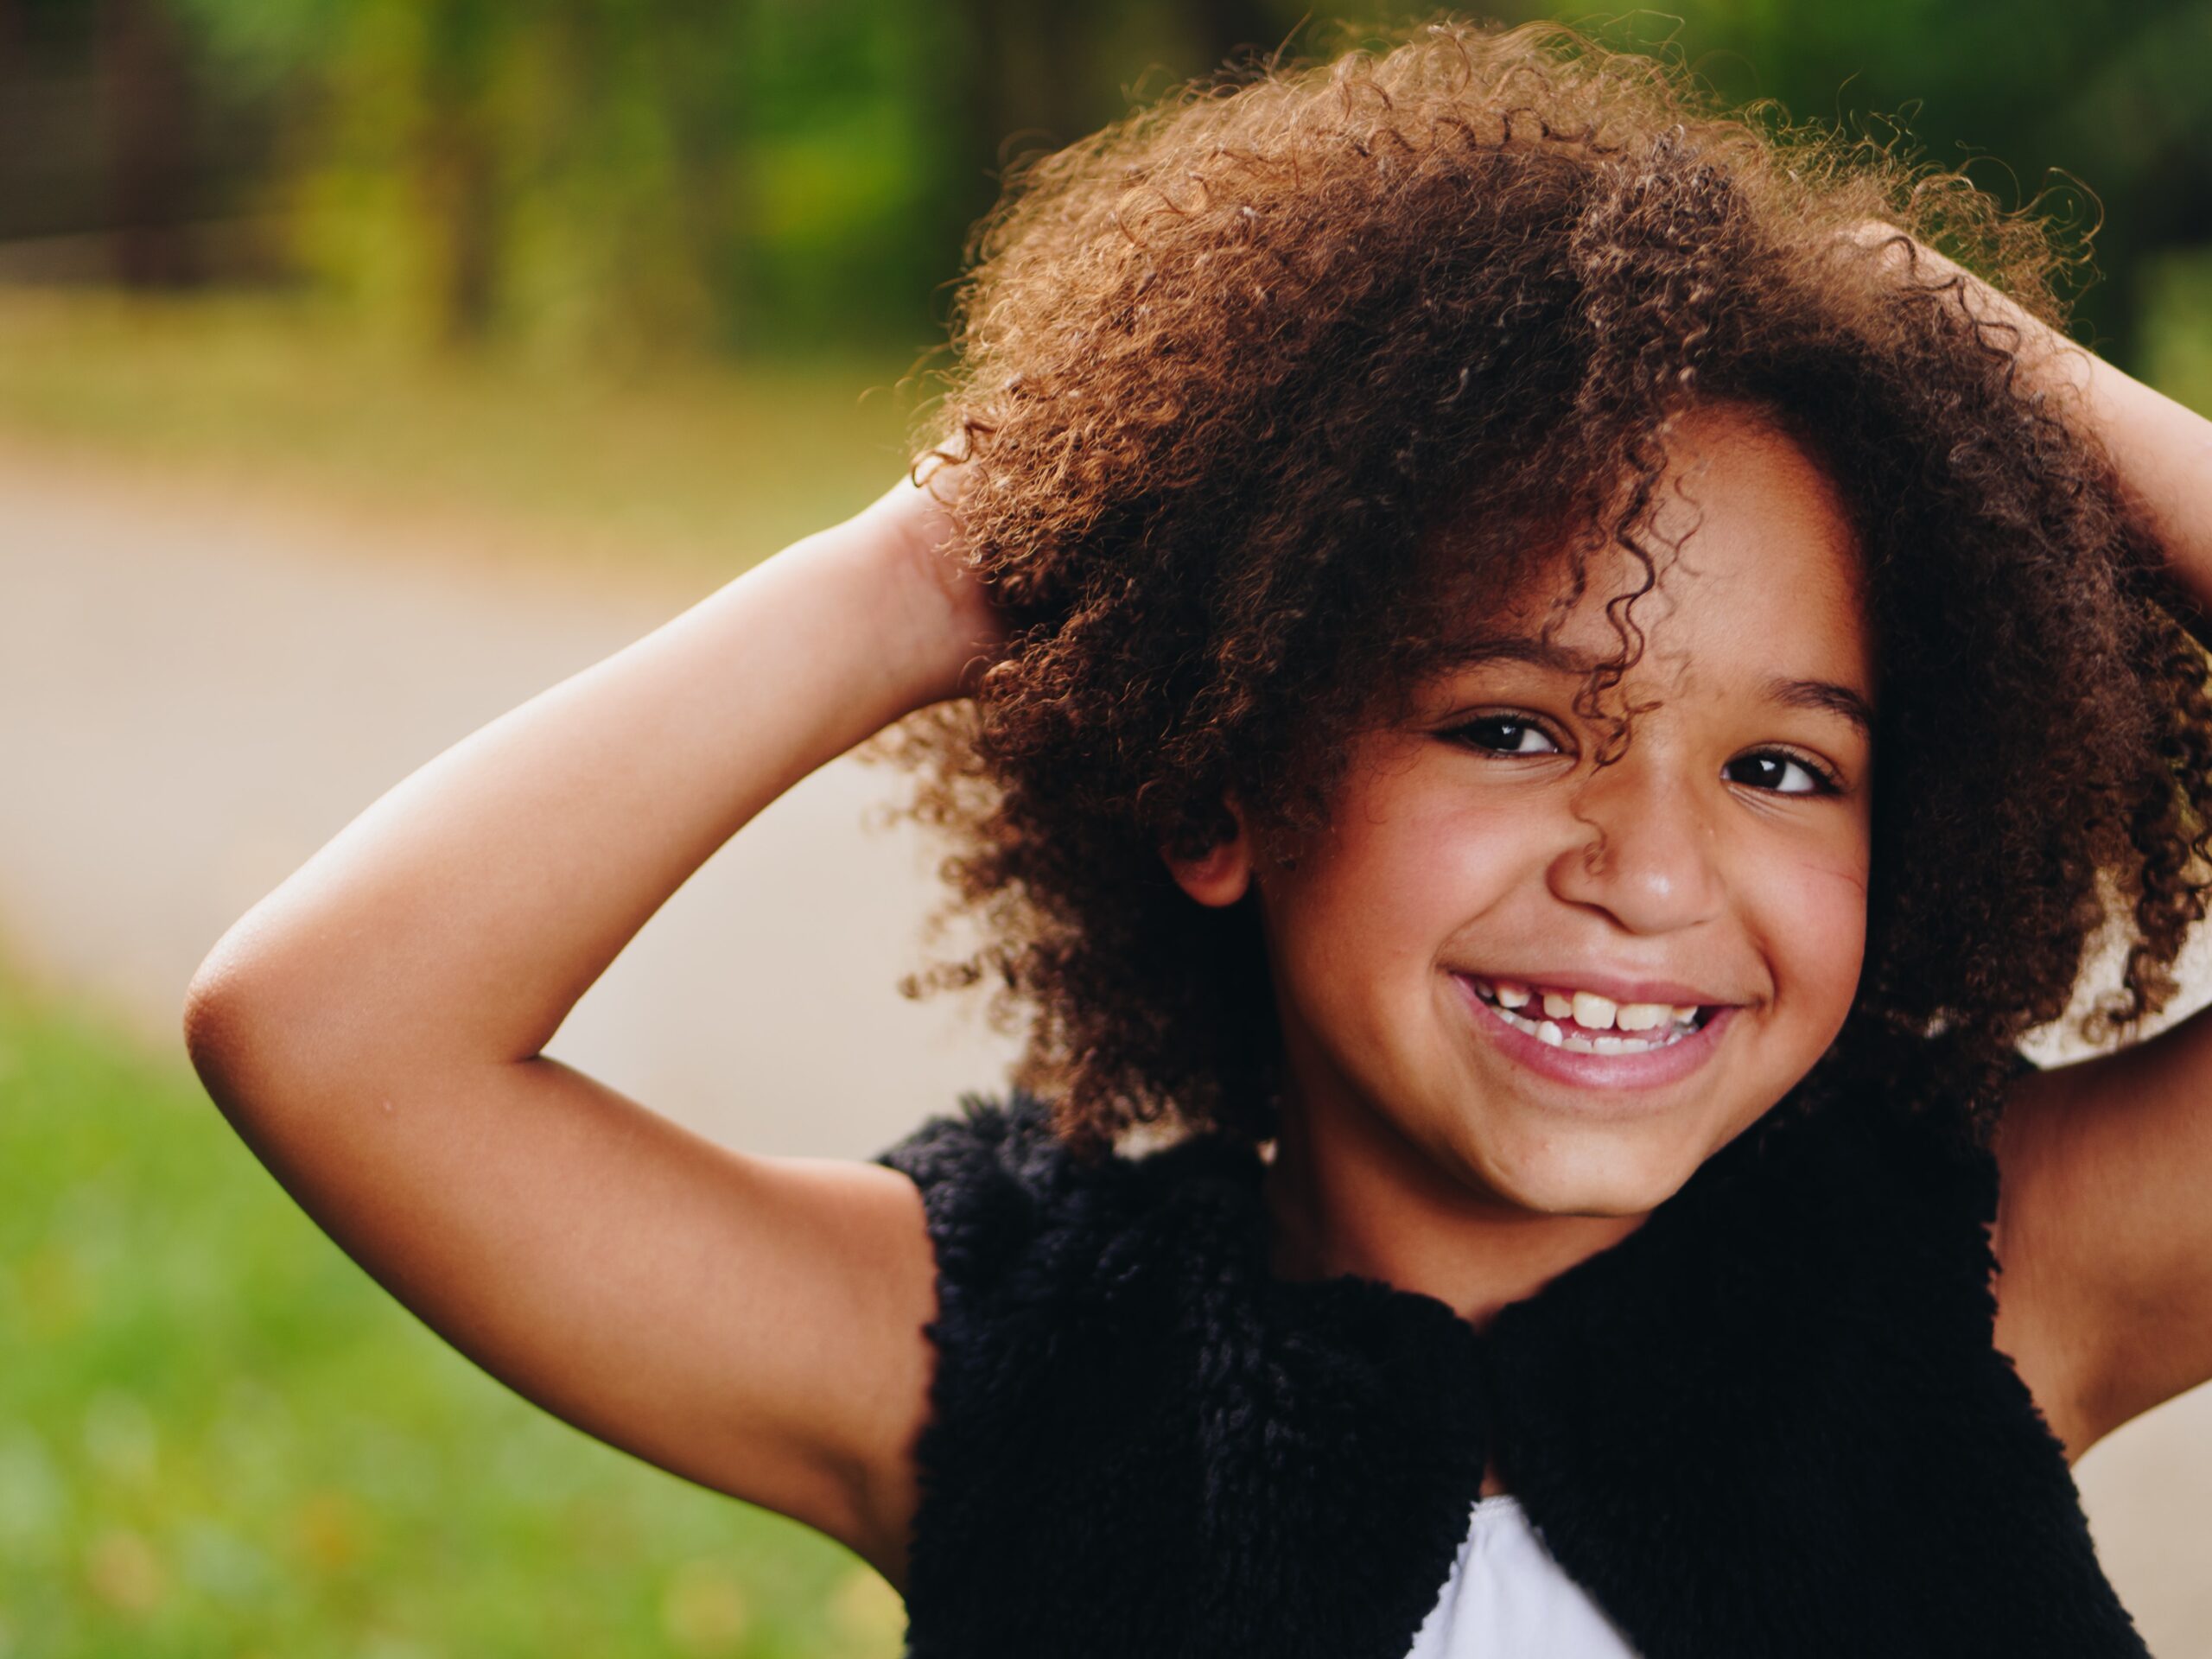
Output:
[1860, 226, 2212, 1458]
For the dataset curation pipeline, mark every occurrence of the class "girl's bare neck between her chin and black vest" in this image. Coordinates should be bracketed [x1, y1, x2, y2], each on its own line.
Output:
[1261, 1102, 1643, 1330]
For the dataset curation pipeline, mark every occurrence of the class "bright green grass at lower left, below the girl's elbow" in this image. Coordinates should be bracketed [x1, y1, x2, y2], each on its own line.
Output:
[0, 969, 902, 1659]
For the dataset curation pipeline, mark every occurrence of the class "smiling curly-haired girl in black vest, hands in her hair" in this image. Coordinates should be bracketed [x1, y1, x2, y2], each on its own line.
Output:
[186, 24, 2212, 1659]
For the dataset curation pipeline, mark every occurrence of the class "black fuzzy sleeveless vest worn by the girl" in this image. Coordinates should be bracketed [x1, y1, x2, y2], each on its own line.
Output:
[876, 1090, 2145, 1659]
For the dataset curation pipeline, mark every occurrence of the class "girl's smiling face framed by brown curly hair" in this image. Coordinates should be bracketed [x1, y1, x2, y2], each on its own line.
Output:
[1177, 396, 1876, 1217]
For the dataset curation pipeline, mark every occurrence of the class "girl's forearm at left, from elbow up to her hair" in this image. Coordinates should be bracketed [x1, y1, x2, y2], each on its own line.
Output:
[193, 471, 984, 1071]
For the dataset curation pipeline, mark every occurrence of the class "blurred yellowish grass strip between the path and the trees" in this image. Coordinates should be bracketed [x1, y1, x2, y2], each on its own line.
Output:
[0, 288, 925, 573]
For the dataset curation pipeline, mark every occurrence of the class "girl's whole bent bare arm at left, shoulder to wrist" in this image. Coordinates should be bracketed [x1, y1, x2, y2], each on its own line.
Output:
[183, 462, 1002, 1586]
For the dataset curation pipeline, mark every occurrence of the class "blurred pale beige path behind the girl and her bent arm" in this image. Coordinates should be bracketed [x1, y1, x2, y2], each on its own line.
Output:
[0, 449, 2212, 1659]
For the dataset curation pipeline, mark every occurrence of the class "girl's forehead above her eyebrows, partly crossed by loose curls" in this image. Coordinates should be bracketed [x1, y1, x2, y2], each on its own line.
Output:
[1453, 404, 1876, 702]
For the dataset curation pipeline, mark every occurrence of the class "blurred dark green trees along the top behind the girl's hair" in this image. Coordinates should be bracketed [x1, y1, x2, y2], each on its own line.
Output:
[13, 0, 2212, 360]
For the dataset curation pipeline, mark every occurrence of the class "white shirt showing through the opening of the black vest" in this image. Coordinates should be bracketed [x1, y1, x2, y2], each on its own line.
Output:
[1407, 1496, 1637, 1659]
